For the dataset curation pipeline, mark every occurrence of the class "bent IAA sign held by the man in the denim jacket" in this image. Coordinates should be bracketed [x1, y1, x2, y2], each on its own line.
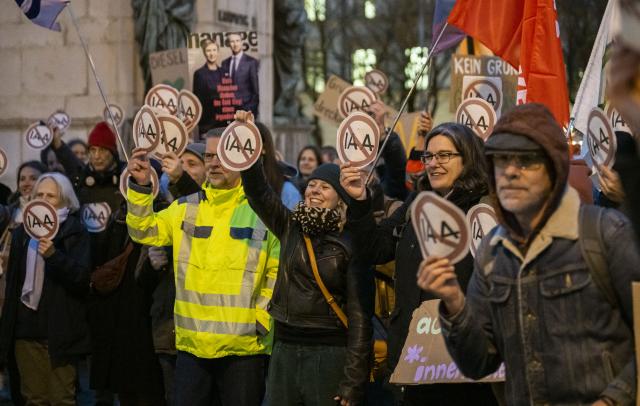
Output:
[411, 192, 471, 264]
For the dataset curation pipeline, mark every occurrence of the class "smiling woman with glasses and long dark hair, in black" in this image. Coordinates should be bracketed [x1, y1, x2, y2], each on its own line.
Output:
[341, 123, 496, 406]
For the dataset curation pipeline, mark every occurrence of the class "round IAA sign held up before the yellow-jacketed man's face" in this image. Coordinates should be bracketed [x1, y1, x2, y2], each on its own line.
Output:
[217, 121, 262, 172]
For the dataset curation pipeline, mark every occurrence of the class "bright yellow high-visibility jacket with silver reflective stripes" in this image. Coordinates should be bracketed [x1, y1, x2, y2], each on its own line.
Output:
[127, 183, 280, 358]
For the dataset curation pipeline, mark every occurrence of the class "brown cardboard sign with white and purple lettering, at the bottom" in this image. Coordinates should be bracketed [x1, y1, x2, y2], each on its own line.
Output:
[390, 300, 506, 386]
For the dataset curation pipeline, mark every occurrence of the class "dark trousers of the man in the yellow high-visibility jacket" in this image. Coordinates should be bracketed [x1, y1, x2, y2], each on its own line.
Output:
[175, 351, 269, 406]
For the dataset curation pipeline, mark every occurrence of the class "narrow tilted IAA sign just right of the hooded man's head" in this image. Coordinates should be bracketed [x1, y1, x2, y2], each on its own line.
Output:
[587, 107, 616, 168]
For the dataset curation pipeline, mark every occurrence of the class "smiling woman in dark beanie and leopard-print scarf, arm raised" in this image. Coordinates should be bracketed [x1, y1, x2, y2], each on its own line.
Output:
[236, 108, 373, 406]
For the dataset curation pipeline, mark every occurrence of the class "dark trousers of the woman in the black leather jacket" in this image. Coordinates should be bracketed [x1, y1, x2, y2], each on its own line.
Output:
[267, 341, 347, 406]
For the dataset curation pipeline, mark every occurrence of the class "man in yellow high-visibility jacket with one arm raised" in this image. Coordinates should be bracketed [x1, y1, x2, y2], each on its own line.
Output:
[122, 130, 280, 406]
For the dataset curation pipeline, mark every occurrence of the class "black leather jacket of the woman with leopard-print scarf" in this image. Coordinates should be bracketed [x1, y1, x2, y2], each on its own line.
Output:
[242, 162, 373, 404]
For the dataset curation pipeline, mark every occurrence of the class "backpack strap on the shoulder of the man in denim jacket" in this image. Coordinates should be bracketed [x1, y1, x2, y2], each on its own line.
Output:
[578, 205, 619, 308]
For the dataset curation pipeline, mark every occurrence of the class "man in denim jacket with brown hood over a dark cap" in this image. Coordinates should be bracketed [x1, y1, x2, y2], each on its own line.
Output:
[418, 104, 640, 406]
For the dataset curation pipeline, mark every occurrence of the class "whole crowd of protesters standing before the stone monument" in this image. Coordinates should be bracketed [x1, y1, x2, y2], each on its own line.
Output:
[0, 43, 640, 406]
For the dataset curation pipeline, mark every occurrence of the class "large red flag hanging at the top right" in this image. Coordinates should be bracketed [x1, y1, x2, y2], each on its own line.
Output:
[447, 0, 569, 127]
